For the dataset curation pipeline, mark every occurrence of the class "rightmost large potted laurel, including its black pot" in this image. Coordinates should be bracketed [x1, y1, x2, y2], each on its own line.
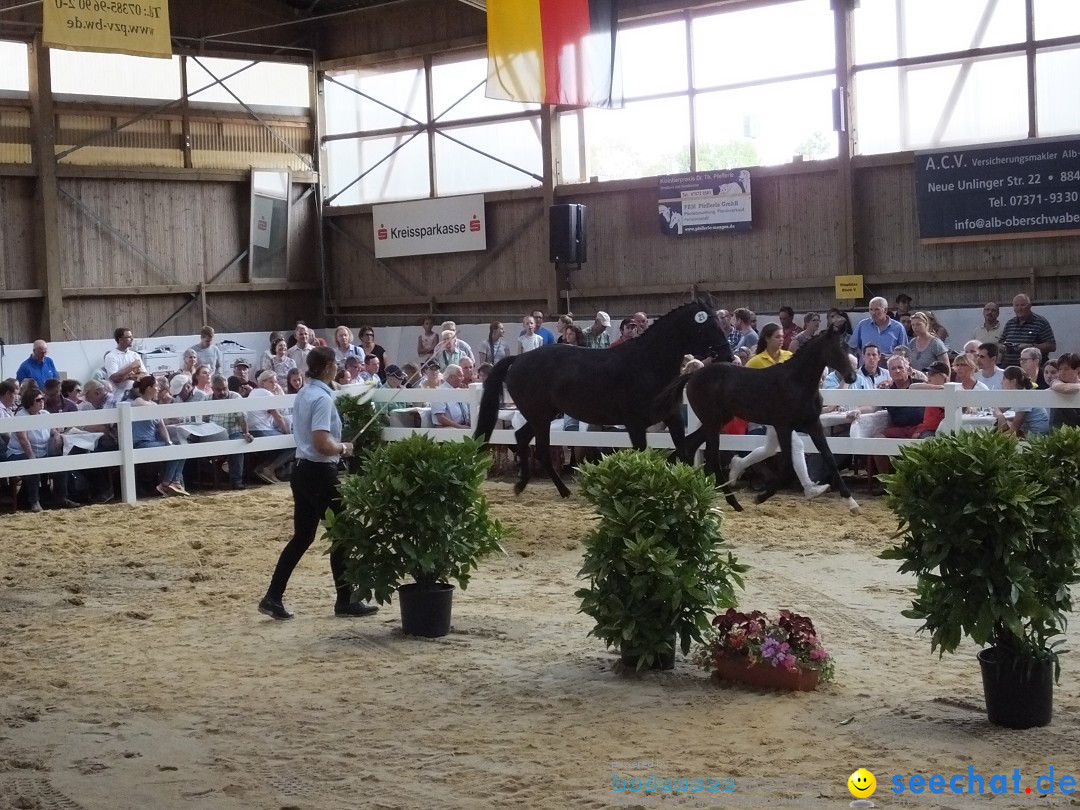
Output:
[881, 428, 1080, 728]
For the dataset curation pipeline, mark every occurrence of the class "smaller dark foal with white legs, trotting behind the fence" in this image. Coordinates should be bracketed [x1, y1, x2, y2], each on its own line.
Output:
[658, 326, 859, 512]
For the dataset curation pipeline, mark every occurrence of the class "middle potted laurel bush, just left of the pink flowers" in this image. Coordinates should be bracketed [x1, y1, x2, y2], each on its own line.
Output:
[576, 450, 746, 670]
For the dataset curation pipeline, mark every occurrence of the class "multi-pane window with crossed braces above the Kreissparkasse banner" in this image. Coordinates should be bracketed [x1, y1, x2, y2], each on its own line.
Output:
[323, 54, 543, 205]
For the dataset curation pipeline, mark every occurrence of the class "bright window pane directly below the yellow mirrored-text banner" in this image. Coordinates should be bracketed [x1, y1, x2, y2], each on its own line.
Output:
[50, 49, 180, 100]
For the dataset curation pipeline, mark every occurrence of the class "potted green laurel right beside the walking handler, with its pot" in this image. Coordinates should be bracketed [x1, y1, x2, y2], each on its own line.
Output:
[326, 434, 507, 637]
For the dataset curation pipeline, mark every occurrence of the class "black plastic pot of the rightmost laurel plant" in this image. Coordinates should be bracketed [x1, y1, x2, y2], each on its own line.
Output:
[978, 647, 1054, 728]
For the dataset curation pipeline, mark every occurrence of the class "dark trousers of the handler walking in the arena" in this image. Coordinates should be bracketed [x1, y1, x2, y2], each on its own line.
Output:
[267, 459, 352, 606]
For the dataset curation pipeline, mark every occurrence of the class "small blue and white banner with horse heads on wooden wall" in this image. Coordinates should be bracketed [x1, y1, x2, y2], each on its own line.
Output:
[660, 168, 752, 237]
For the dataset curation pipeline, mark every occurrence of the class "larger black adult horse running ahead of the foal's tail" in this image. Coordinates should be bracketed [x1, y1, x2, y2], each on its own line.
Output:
[474, 300, 732, 498]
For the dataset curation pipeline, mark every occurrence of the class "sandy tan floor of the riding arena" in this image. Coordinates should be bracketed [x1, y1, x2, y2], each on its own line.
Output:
[0, 482, 1080, 810]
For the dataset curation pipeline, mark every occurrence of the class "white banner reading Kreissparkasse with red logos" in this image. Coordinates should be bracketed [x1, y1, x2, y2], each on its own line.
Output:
[372, 194, 487, 259]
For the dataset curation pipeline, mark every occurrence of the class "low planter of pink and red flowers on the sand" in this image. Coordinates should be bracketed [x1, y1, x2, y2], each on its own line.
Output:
[694, 608, 834, 683]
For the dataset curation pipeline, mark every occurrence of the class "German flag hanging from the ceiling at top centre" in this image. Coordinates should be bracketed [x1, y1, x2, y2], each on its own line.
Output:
[486, 0, 622, 108]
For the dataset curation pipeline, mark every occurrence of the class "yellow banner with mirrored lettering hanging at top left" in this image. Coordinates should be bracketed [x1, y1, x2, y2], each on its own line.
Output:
[41, 0, 173, 58]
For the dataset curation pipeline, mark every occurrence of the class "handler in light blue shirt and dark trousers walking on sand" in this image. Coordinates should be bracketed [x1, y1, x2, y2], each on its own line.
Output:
[259, 348, 378, 619]
